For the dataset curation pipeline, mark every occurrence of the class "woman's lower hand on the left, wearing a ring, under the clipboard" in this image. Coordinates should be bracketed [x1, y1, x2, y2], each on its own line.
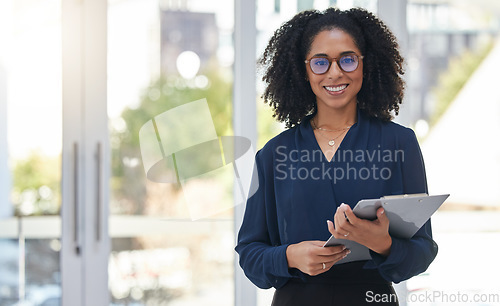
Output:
[286, 241, 351, 276]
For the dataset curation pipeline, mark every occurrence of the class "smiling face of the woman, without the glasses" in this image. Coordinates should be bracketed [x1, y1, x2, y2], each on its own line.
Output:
[306, 29, 363, 112]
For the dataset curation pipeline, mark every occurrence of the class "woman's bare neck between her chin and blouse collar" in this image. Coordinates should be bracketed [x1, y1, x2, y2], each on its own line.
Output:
[313, 105, 358, 129]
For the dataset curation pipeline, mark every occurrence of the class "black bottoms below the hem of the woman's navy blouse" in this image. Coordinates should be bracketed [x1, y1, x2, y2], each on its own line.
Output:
[271, 280, 399, 306]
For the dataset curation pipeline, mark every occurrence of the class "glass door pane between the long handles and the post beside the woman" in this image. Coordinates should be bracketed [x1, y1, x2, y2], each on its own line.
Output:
[108, 0, 235, 306]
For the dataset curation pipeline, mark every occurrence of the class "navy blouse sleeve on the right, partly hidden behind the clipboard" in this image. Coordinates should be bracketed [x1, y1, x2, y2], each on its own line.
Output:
[368, 129, 438, 283]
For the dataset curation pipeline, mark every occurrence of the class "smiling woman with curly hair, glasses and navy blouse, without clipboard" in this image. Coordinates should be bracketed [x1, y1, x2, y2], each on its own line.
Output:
[236, 8, 437, 306]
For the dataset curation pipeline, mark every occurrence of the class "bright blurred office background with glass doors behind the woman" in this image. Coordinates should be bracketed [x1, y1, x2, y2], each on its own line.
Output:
[0, 0, 500, 306]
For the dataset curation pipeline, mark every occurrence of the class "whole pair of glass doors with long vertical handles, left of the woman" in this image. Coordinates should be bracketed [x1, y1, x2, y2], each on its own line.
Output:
[0, 0, 253, 306]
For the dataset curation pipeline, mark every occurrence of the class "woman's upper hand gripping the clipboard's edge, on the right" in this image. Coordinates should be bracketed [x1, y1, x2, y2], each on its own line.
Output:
[327, 204, 392, 256]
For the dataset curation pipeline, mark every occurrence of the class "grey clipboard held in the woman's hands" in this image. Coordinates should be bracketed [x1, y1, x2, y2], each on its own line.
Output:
[323, 193, 450, 264]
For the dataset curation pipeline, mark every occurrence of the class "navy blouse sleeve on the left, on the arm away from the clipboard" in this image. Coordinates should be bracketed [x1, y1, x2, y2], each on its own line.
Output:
[235, 151, 292, 289]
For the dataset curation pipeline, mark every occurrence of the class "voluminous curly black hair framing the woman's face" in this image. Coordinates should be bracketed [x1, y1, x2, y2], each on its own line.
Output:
[258, 8, 405, 128]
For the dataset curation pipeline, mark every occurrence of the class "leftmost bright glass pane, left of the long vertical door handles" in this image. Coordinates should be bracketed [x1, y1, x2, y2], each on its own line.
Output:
[0, 0, 62, 305]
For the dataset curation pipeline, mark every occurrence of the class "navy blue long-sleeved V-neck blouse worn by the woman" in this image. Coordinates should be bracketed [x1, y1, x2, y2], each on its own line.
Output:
[236, 111, 437, 289]
